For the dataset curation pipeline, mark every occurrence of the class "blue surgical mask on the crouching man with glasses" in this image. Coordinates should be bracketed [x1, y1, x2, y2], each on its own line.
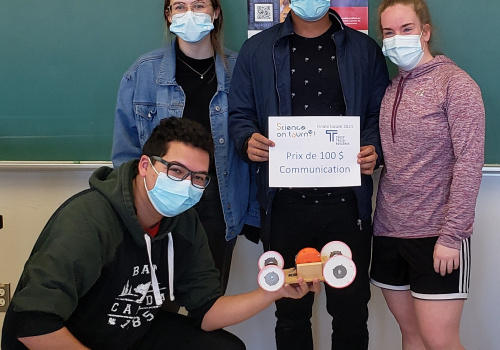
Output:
[144, 161, 203, 217]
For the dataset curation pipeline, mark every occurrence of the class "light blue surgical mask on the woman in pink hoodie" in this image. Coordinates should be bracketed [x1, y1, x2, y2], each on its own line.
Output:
[382, 33, 424, 71]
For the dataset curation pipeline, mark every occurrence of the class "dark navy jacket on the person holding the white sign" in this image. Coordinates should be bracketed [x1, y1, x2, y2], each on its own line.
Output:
[229, 9, 389, 243]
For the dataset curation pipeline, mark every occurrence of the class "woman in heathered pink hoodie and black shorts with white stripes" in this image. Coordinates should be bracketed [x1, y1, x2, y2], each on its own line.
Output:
[371, 0, 485, 350]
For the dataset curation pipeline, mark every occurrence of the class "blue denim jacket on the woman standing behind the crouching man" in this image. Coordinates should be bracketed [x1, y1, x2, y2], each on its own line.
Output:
[111, 41, 260, 240]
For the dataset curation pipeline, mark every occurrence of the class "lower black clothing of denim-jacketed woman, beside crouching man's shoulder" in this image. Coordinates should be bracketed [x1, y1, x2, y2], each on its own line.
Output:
[194, 179, 236, 293]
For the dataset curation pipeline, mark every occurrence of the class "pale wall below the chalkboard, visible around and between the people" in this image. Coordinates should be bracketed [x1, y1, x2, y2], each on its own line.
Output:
[0, 164, 500, 350]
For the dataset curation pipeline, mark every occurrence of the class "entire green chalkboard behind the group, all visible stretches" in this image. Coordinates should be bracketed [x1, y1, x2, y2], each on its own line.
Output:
[0, 0, 500, 164]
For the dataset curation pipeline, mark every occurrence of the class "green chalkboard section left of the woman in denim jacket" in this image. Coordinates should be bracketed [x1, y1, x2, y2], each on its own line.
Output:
[0, 0, 164, 161]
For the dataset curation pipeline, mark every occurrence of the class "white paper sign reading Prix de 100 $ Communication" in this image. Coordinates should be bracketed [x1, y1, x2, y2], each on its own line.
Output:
[269, 116, 361, 188]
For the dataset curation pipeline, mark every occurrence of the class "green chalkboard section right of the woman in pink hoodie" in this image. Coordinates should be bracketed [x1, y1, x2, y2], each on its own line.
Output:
[422, 0, 500, 165]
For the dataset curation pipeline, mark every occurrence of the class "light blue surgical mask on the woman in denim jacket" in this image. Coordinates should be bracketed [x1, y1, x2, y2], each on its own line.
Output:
[170, 11, 214, 43]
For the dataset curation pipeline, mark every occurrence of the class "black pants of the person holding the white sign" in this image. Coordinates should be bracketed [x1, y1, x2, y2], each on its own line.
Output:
[270, 190, 372, 350]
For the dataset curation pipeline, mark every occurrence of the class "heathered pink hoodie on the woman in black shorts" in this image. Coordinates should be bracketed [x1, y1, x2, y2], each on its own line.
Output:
[374, 56, 485, 249]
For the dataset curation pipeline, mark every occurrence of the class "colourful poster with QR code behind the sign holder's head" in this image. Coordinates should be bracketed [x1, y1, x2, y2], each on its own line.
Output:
[247, 0, 368, 37]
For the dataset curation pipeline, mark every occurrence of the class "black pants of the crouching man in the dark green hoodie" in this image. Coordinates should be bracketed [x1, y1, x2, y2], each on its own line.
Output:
[130, 311, 245, 350]
